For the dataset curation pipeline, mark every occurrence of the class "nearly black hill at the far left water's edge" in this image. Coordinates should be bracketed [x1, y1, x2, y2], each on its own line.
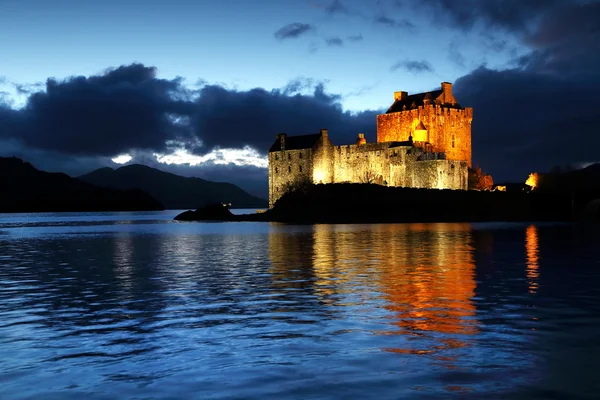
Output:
[0, 157, 163, 212]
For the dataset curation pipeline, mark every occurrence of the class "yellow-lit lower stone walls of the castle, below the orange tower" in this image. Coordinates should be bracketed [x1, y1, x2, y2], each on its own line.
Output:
[269, 131, 468, 207]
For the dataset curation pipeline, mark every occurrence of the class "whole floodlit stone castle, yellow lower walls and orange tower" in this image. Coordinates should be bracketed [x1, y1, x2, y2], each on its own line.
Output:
[269, 82, 473, 207]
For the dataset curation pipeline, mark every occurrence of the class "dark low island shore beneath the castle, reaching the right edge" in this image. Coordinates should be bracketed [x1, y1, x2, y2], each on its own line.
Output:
[176, 183, 597, 223]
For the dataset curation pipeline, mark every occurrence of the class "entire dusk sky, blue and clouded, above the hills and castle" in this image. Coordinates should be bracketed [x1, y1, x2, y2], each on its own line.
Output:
[0, 0, 600, 197]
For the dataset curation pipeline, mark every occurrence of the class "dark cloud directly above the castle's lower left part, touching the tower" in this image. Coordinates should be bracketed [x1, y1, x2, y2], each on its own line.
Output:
[192, 83, 377, 154]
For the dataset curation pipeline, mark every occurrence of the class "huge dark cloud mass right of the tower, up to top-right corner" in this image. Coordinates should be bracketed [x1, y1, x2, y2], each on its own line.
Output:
[455, 4, 600, 179]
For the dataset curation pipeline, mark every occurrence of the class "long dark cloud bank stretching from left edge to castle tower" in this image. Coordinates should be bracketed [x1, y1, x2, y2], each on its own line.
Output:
[0, 64, 377, 172]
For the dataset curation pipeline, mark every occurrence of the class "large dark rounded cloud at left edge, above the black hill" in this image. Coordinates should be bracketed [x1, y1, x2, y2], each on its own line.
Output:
[0, 64, 191, 156]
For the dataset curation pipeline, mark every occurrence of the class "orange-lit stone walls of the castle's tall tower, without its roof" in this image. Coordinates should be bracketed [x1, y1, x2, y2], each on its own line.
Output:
[377, 104, 473, 166]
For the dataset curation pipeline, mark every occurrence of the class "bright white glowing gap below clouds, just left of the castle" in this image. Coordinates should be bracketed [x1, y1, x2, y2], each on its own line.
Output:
[153, 146, 268, 168]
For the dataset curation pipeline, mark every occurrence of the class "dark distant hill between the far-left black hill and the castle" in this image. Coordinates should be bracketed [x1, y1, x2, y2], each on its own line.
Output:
[79, 164, 267, 209]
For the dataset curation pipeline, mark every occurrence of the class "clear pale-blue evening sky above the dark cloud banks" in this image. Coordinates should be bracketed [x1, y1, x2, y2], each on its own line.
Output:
[0, 0, 520, 110]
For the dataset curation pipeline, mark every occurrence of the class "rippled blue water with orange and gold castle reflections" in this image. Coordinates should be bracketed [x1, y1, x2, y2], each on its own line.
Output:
[0, 211, 600, 399]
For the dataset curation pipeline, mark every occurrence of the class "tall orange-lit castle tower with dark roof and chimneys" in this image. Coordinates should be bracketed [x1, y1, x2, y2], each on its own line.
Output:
[377, 82, 473, 167]
